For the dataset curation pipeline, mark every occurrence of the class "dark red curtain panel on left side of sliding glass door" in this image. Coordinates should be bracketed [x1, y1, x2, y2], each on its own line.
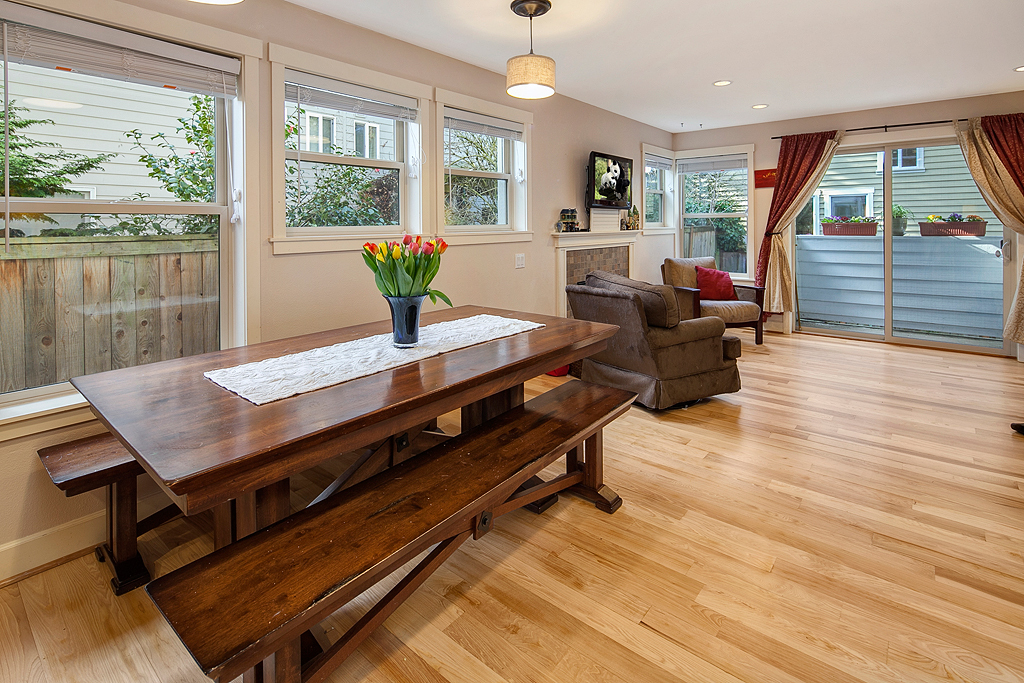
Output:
[754, 130, 836, 287]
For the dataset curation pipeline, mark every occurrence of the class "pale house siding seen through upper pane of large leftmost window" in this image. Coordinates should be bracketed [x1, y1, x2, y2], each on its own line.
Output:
[10, 63, 195, 201]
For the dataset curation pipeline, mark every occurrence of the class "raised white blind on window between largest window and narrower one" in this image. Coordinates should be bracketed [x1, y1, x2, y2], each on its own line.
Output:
[285, 69, 419, 121]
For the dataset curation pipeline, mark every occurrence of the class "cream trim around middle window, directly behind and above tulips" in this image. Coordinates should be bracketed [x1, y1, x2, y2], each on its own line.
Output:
[269, 43, 433, 254]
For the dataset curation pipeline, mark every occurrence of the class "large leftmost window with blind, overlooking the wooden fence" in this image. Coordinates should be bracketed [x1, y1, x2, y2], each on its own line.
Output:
[0, 7, 235, 400]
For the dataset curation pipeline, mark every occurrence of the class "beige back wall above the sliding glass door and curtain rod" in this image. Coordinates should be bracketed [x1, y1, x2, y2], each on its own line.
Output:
[672, 91, 1024, 286]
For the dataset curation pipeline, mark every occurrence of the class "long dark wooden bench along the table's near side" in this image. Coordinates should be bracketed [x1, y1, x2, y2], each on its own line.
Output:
[146, 381, 636, 683]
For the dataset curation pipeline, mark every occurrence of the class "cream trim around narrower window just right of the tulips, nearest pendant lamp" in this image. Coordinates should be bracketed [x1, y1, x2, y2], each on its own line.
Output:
[432, 88, 534, 245]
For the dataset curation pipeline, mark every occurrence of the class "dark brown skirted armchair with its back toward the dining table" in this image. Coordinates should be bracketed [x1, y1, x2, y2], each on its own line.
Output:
[565, 270, 740, 410]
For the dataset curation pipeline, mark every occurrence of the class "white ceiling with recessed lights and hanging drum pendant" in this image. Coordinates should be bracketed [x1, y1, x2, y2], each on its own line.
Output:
[282, 0, 1024, 132]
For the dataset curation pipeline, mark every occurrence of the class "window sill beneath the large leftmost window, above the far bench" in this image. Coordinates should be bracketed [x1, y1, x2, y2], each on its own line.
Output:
[0, 382, 95, 442]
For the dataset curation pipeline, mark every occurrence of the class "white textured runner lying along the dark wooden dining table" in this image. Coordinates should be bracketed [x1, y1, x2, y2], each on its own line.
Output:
[204, 314, 544, 405]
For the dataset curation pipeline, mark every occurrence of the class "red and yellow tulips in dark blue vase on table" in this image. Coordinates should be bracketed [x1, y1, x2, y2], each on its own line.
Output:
[362, 234, 452, 348]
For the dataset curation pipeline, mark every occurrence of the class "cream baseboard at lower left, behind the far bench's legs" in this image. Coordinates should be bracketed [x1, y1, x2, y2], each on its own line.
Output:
[0, 492, 168, 588]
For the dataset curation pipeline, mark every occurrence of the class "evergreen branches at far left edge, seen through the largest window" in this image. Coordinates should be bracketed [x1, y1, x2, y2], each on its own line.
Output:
[0, 98, 117, 223]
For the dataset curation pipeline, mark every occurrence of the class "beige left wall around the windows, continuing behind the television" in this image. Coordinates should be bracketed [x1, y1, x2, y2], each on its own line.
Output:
[0, 0, 673, 581]
